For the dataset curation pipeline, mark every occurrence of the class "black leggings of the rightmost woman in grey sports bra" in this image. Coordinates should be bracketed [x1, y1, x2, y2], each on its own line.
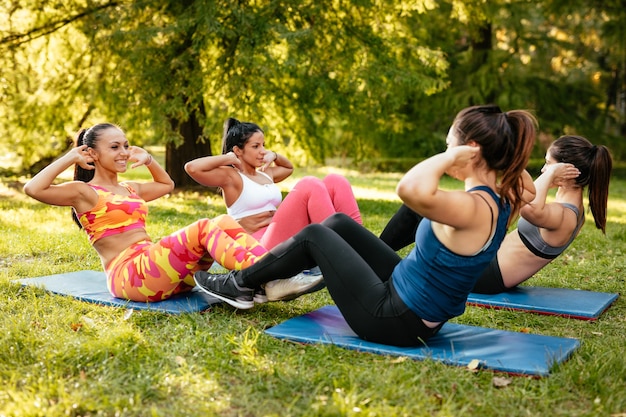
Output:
[380, 204, 510, 294]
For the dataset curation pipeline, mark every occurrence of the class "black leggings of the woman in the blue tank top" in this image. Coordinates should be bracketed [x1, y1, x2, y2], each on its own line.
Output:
[236, 213, 441, 346]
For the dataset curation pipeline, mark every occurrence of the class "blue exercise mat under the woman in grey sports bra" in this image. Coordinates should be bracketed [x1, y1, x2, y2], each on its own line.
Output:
[467, 287, 618, 320]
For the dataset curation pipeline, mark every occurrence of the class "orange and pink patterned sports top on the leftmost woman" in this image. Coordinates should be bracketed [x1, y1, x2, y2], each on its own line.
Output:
[77, 184, 148, 244]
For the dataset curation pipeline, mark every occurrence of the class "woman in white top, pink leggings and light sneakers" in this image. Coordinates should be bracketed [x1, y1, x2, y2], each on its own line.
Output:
[185, 118, 362, 302]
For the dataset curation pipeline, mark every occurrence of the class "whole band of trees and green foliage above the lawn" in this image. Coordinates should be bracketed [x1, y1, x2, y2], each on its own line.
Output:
[0, 0, 626, 172]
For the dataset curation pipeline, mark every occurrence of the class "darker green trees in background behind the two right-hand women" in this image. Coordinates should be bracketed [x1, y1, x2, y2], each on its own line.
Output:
[370, 2, 626, 159]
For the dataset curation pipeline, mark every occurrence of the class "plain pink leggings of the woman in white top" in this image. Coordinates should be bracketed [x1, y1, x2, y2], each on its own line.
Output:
[252, 174, 363, 250]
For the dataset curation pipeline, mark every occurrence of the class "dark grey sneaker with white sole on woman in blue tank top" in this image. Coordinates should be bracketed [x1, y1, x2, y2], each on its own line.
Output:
[193, 271, 254, 310]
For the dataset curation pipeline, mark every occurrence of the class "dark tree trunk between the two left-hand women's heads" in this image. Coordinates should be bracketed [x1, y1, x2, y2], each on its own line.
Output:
[165, 107, 212, 188]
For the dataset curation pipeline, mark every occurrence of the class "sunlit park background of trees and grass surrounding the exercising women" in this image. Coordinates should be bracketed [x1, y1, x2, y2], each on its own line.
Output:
[0, 0, 626, 417]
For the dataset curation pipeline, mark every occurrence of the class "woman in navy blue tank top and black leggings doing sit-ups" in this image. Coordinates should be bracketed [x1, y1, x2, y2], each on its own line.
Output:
[194, 106, 536, 346]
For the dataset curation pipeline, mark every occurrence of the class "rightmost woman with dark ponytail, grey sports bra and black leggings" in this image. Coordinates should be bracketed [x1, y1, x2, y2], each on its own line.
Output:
[380, 135, 613, 294]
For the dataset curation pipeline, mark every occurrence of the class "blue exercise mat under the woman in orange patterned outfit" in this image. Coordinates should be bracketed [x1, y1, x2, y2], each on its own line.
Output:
[18, 271, 221, 314]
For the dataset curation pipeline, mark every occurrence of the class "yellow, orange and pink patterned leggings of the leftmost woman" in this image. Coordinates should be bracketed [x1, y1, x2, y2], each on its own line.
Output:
[105, 215, 267, 301]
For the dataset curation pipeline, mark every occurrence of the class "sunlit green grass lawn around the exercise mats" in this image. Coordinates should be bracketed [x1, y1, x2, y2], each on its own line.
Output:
[0, 157, 626, 417]
